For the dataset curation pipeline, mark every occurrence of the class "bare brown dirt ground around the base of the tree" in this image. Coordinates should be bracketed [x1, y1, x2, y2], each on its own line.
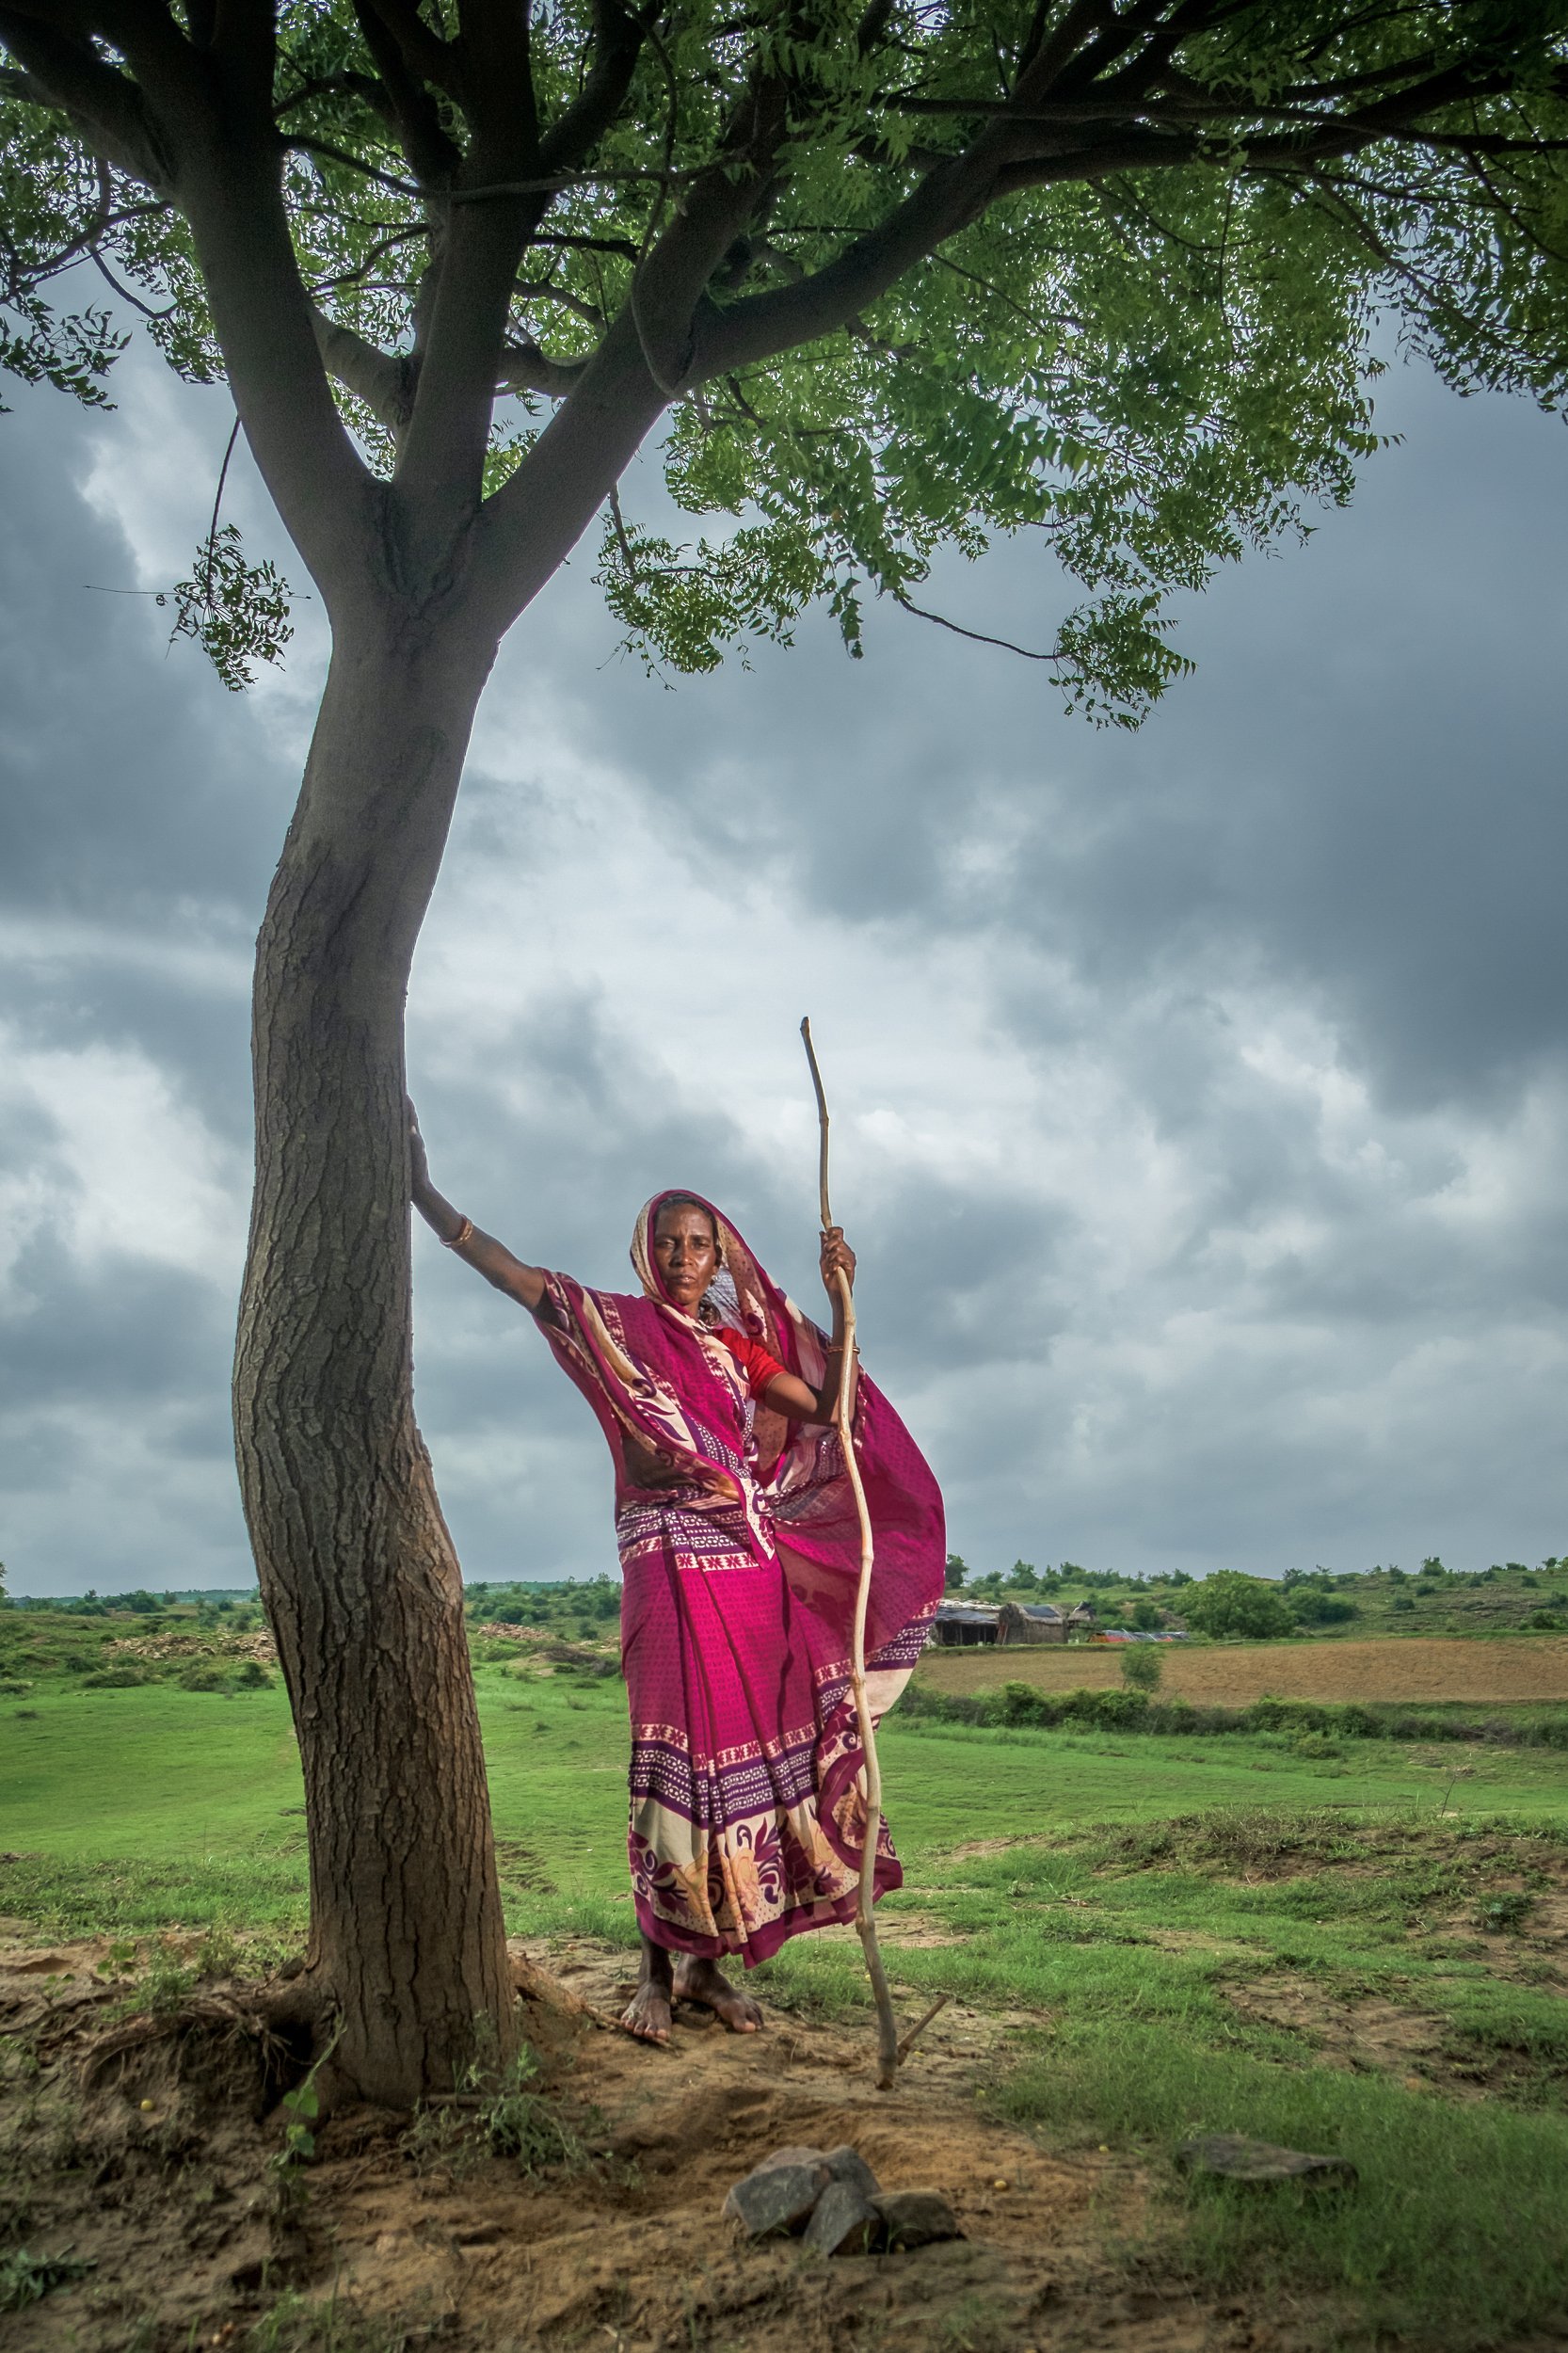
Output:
[0, 1942, 1300, 2353]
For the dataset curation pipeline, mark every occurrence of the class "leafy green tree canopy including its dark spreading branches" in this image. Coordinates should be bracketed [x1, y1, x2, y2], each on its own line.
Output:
[0, 0, 1568, 720]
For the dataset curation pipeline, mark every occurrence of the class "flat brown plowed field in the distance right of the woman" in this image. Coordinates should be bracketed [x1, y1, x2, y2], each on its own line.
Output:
[920, 1636, 1568, 1708]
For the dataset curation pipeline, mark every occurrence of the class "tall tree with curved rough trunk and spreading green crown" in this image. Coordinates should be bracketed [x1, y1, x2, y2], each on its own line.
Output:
[0, 0, 1568, 2102]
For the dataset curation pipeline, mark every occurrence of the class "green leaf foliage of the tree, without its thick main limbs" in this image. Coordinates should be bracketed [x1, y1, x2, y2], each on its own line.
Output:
[0, 0, 1568, 725]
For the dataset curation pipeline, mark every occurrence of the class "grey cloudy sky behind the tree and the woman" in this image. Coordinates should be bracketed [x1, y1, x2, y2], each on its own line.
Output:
[0, 317, 1568, 1593]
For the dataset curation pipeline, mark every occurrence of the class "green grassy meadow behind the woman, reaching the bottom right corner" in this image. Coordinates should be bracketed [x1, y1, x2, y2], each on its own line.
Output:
[0, 1661, 1568, 2348]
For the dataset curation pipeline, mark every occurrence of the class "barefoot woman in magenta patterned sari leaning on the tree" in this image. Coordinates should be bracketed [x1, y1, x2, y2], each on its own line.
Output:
[412, 1123, 947, 2042]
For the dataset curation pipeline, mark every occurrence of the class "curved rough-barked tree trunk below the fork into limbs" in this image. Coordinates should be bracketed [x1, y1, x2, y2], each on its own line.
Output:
[233, 615, 516, 2106]
